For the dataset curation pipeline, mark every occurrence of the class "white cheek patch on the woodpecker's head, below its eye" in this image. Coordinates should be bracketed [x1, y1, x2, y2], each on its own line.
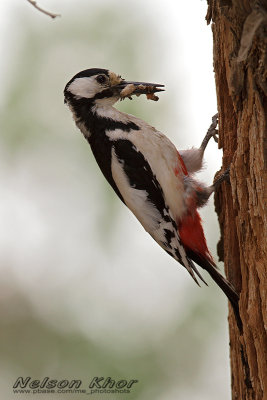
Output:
[68, 75, 104, 99]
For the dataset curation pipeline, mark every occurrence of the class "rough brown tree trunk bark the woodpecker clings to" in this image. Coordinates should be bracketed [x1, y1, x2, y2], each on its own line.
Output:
[206, 0, 267, 400]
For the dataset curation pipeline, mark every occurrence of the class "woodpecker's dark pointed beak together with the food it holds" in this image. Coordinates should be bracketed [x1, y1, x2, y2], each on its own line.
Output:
[112, 81, 164, 100]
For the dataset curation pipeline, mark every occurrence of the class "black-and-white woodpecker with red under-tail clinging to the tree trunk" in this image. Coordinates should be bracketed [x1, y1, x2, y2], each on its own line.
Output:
[64, 68, 240, 325]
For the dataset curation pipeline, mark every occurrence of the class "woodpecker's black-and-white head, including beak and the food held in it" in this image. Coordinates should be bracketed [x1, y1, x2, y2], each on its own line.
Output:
[64, 68, 164, 106]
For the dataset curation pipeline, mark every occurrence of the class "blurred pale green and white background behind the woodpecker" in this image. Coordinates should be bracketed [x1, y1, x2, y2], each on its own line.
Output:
[0, 0, 230, 400]
